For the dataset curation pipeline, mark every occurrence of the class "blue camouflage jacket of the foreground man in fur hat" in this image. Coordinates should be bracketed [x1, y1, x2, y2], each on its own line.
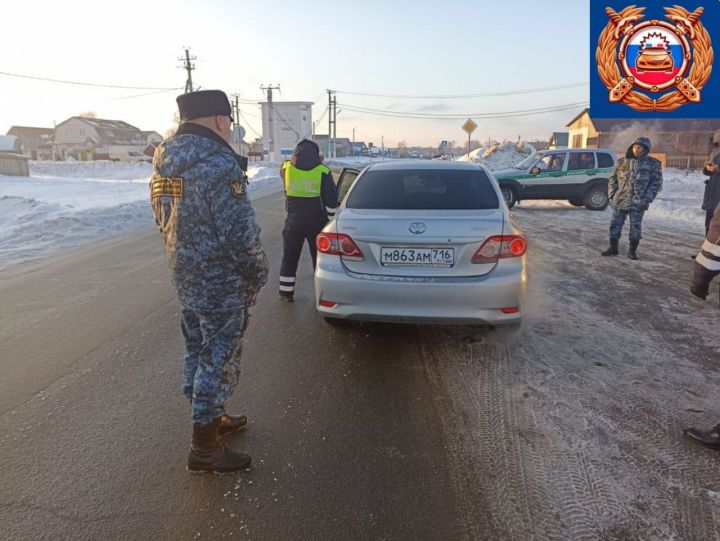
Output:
[150, 125, 268, 311]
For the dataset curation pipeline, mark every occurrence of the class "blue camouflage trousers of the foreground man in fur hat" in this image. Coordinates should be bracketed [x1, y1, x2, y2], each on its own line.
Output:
[180, 308, 249, 424]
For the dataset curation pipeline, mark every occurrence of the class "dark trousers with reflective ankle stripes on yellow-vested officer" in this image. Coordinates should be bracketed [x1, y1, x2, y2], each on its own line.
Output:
[280, 213, 327, 295]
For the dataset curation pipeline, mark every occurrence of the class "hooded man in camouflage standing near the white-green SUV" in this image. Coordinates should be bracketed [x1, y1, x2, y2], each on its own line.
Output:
[602, 137, 662, 259]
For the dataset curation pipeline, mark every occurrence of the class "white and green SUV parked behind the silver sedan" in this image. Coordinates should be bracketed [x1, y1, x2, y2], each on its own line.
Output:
[493, 148, 616, 210]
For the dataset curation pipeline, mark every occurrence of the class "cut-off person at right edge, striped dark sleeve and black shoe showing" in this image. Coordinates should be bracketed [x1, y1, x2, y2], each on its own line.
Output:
[685, 205, 720, 449]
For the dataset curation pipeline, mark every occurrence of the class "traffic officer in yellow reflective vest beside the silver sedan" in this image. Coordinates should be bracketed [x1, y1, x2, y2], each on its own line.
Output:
[280, 139, 338, 302]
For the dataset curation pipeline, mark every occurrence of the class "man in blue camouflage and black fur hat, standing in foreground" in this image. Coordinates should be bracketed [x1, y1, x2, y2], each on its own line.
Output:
[150, 90, 268, 473]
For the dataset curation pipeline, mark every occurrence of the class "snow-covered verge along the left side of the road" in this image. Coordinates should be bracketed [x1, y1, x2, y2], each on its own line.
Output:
[0, 161, 281, 269]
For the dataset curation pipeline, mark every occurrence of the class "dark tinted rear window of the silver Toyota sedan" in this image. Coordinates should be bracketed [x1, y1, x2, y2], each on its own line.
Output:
[345, 169, 500, 210]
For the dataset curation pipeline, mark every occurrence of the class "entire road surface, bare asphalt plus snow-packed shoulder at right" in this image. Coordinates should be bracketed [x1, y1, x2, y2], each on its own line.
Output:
[0, 195, 720, 541]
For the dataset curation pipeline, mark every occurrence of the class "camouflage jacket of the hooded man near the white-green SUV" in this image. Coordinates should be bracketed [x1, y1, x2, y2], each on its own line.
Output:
[608, 156, 662, 210]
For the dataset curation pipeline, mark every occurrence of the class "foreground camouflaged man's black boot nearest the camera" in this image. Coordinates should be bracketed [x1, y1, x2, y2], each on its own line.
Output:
[187, 417, 251, 473]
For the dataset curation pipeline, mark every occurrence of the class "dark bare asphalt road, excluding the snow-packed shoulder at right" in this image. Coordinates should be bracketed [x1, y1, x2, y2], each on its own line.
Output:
[0, 195, 463, 539]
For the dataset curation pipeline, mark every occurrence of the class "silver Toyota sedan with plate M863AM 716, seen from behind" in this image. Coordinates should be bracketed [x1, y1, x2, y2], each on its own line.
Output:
[315, 161, 527, 325]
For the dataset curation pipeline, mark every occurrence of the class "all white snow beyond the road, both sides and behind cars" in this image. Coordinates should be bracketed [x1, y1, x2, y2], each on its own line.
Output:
[0, 150, 706, 268]
